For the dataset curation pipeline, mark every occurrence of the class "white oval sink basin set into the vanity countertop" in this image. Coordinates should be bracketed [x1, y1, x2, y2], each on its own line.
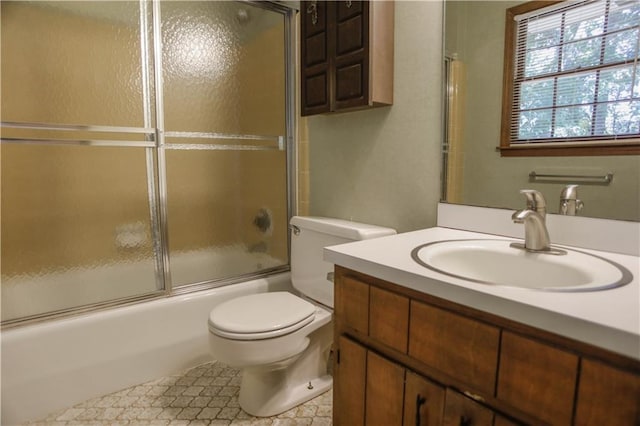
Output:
[411, 240, 633, 291]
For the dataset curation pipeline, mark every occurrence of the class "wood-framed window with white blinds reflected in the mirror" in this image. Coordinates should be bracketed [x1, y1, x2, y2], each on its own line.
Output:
[500, 0, 640, 155]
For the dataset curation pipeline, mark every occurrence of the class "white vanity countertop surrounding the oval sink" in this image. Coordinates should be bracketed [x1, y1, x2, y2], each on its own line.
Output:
[324, 227, 640, 360]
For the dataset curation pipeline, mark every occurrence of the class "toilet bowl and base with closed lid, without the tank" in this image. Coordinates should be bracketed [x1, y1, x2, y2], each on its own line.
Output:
[209, 292, 333, 417]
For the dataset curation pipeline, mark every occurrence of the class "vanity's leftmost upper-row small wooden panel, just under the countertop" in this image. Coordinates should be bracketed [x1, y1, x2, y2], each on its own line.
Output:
[334, 275, 369, 334]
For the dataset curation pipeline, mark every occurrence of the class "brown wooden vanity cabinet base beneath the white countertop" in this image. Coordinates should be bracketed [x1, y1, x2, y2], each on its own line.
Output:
[333, 266, 640, 426]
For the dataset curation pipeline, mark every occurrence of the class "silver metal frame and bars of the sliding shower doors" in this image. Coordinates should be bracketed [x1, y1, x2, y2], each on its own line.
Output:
[2, 0, 297, 328]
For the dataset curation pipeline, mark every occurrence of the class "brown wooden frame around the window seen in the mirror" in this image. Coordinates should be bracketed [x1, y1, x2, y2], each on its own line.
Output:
[498, 0, 640, 157]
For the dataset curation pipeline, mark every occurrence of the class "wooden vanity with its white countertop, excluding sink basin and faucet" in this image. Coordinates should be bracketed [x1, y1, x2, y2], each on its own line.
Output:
[325, 228, 640, 426]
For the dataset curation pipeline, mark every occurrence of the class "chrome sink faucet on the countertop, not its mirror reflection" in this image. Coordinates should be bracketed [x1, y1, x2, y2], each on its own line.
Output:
[511, 189, 551, 252]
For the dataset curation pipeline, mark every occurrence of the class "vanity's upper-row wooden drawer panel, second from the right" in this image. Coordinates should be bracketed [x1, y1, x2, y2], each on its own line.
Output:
[497, 331, 578, 425]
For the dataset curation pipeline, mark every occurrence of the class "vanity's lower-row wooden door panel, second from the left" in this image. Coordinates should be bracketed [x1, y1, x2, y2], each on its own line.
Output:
[366, 351, 404, 426]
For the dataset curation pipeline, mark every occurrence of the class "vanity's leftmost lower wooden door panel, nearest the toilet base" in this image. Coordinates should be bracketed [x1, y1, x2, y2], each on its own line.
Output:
[333, 336, 367, 426]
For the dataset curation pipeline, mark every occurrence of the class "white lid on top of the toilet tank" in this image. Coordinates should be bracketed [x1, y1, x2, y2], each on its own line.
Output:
[290, 216, 396, 241]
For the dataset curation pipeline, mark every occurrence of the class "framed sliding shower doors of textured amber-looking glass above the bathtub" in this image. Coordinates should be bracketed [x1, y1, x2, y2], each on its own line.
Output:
[0, 1, 295, 325]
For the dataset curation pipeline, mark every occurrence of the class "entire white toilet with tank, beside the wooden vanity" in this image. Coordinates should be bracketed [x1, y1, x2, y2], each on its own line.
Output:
[209, 216, 396, 417]
